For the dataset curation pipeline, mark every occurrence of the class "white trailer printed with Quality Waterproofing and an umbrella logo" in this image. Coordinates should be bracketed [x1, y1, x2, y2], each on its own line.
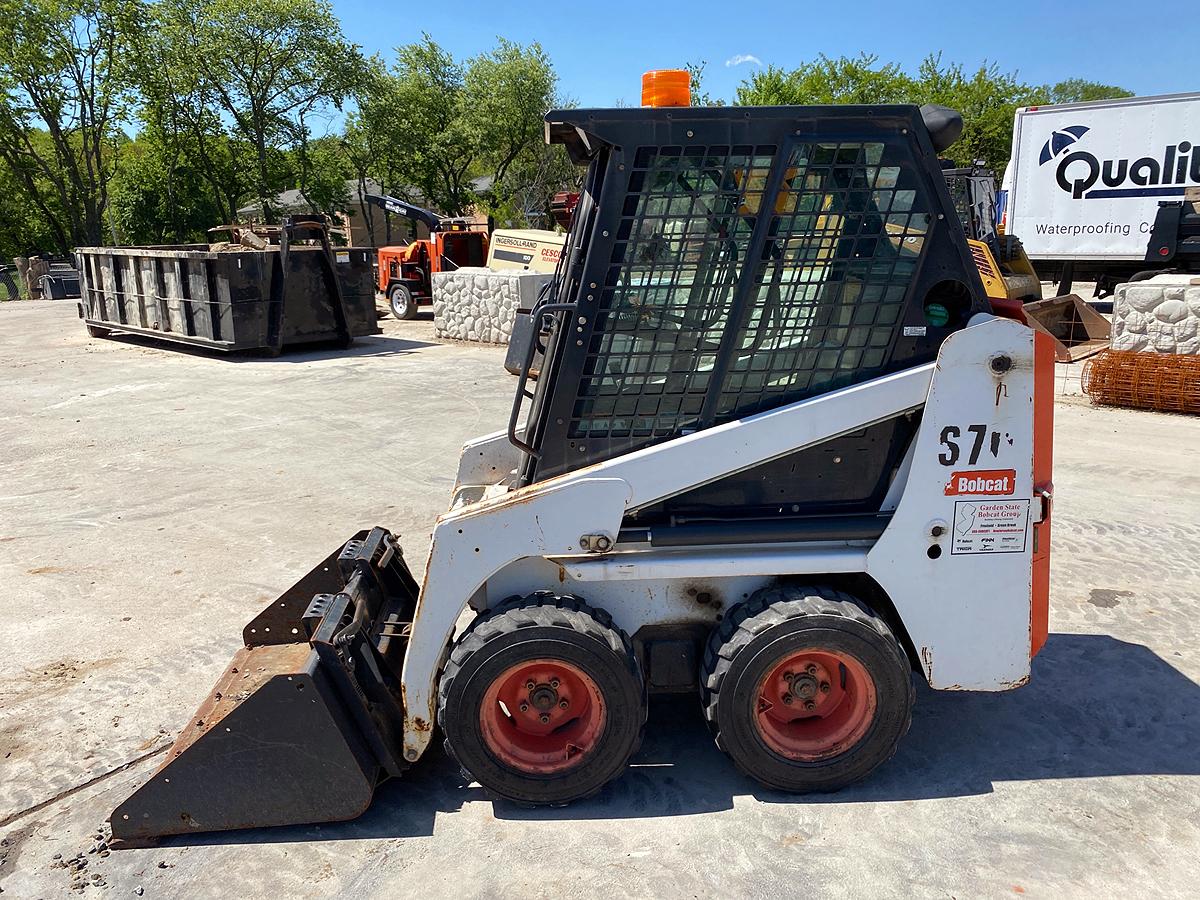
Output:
[1000, 92, 1200, 296]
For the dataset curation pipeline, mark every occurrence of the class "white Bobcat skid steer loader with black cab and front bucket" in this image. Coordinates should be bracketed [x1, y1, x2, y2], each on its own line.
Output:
[112, 88, 1054, 839]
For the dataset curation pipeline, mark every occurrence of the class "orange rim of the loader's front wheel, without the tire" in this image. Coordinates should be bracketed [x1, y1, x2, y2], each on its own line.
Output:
[479, 659, 607, 775]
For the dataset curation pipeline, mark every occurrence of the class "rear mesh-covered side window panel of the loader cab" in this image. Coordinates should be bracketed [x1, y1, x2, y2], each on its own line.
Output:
[716, 144, 929, 421]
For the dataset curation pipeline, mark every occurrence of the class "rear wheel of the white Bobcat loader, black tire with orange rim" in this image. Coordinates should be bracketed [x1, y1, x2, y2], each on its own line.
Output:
[701, 586, 916, 792]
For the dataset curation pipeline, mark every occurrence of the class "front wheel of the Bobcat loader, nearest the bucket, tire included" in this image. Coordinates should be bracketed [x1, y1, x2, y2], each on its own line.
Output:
[438, 592, 646, 805]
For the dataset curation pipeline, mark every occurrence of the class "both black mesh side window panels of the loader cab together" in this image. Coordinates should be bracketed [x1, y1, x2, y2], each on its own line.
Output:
[570, 143, 928, 443]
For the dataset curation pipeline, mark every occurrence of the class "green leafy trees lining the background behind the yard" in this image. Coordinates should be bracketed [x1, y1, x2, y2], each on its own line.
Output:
[0, 0, 1128, 258]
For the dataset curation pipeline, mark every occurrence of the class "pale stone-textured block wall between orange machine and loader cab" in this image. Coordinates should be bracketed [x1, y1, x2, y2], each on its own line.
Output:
[433, 268, 551, 344]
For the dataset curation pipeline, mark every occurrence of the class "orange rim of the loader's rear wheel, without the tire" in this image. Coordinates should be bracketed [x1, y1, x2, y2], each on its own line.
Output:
[755, 649, 877, 762]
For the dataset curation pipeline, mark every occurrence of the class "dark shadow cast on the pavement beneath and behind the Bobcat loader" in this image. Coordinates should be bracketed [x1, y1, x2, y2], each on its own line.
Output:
[164, 634, 1200, 845]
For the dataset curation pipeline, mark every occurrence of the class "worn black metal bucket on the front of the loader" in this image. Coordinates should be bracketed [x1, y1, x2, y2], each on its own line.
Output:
[112, 528, 418, 840]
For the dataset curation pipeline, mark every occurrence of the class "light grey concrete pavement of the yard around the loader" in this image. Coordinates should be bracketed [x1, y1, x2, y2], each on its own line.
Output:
[0, 302, 1200, 899]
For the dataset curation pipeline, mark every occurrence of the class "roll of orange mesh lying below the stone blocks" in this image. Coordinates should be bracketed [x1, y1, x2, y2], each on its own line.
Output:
[1084, 350, 1200, 414]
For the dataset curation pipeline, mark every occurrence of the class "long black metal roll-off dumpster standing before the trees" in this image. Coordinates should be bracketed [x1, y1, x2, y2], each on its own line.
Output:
[76, 244, 379, 353]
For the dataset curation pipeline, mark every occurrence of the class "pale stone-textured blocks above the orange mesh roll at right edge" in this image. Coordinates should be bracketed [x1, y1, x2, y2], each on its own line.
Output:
[1112, 275, 1200, 354]
